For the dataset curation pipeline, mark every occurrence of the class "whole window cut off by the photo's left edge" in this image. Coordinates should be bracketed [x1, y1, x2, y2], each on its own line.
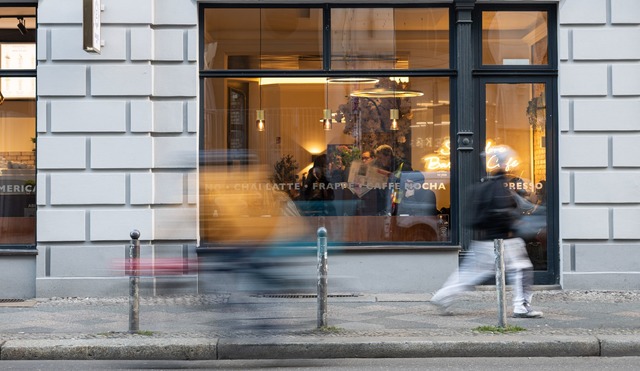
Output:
[0, 7, 36, 246]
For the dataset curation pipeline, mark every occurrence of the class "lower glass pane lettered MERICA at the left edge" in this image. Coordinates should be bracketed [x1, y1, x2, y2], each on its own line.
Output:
[0, 100, 36, 245]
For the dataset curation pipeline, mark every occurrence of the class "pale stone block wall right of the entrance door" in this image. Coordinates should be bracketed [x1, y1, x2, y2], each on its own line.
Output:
[559, 0, 640, 289]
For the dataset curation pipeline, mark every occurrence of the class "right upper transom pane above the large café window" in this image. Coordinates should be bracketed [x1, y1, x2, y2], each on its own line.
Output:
[331, 8, 449, 70]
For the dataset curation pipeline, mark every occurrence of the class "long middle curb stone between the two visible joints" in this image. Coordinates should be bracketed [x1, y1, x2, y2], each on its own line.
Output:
[218, 336, 600, 359]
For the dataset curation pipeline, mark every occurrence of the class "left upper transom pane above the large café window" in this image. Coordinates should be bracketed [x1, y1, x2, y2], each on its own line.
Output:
[203, 8, 322, 70]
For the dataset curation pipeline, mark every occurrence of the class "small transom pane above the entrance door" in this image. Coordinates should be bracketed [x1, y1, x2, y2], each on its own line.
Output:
[482, 11, 549, 65]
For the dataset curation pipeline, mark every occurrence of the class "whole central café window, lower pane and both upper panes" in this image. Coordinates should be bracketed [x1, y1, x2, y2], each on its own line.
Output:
[200, 7, 452, 245]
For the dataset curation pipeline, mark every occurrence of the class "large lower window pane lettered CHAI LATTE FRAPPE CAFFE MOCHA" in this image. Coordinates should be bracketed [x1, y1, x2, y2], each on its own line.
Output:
[200, 76, 451, 244]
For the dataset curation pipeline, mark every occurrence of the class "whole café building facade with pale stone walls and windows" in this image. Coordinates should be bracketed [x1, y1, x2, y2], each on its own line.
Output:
[0, 0, 640, 298]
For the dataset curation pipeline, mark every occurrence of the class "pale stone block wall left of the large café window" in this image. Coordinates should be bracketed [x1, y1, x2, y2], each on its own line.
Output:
[37, 0, 198, 296]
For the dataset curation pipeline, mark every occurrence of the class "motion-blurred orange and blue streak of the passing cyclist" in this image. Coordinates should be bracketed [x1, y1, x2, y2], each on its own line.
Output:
[200, 156, 315, 293]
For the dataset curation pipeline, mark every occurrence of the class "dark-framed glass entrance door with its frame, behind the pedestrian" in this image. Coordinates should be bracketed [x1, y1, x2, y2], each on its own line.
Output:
[480, 79, 557, 284]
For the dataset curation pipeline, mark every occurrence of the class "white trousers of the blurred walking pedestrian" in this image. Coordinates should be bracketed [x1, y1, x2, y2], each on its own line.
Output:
[431, 238, 533, 312]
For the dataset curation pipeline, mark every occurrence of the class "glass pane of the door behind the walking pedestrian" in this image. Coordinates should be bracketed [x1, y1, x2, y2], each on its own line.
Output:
[485, 84, 547, 270]
